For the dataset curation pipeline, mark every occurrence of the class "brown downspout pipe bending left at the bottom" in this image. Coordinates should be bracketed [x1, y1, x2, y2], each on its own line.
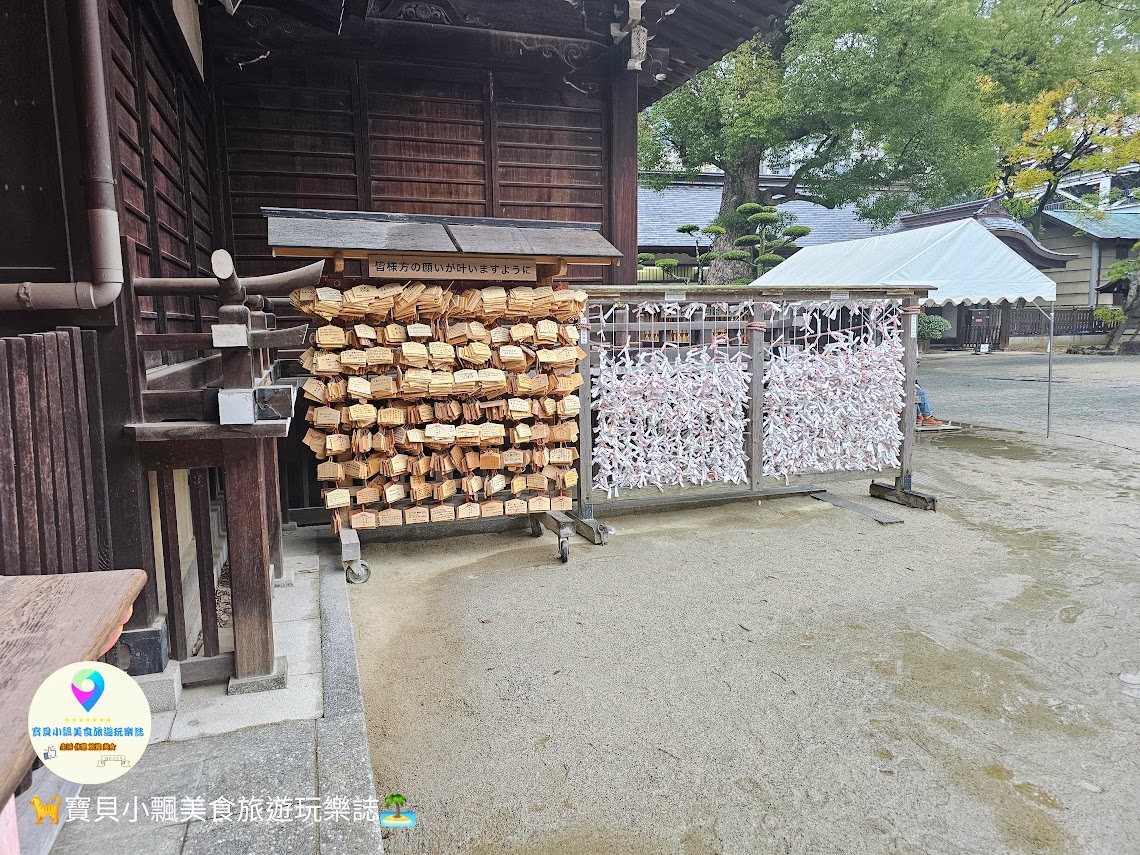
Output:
[0, 0, 123, 310]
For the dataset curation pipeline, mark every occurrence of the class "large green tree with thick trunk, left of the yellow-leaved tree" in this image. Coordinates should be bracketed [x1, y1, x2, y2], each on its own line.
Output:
[640, 0, 993, 284]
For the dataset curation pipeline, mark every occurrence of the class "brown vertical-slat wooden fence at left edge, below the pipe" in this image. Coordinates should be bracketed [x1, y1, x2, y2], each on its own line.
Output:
[0, 327, 109, 576]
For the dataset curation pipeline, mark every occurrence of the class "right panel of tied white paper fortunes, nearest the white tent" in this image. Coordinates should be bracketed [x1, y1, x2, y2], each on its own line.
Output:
[764, 307, 906, 481]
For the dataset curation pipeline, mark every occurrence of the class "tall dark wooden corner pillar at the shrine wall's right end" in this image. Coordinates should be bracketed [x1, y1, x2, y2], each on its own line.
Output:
[604, 71, 637, 285]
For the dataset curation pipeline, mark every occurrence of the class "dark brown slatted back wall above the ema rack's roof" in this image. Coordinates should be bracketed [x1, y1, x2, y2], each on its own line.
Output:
[215, 52, 620, 288]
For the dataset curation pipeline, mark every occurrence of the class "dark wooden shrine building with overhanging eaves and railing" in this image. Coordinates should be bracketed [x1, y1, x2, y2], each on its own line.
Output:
[0, 0, 790, 683]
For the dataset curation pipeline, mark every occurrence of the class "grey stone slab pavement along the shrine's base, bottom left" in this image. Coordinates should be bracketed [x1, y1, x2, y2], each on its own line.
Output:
[54, 536, 382, 855]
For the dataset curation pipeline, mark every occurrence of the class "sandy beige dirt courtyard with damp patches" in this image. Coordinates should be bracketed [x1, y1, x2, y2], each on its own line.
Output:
[350, 351, 1140, 855]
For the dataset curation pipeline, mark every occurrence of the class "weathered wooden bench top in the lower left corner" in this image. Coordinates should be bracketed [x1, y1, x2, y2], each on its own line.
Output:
[0, 570, 146, 807]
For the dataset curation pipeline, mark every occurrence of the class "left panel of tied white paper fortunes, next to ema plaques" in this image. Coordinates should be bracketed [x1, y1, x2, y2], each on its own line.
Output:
[593, 348, 751, 498]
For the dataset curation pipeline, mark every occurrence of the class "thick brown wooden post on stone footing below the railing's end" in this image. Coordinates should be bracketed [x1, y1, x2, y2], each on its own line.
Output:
[222, 439, 274, 678]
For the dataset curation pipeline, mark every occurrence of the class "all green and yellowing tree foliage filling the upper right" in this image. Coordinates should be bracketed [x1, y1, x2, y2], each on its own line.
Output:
[640, 0, 1140, 284]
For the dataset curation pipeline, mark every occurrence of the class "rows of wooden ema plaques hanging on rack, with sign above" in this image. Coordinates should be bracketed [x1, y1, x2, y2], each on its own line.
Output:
[291, 281, 586, 529]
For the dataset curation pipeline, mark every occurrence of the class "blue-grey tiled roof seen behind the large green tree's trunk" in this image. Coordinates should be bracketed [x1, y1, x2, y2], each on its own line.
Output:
[637, 179, 898, 247]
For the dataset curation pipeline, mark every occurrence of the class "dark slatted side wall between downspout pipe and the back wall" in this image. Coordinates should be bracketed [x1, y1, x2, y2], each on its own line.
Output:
[107, 0, 217, 367]
